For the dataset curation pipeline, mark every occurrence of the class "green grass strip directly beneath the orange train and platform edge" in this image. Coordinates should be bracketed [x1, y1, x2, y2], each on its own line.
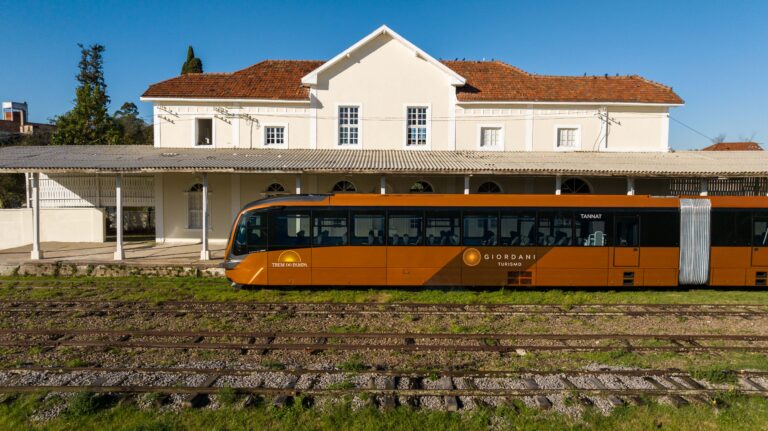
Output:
[0, 276, 768, 306]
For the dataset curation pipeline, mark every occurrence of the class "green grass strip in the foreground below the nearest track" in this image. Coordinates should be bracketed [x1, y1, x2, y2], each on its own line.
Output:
[0, 394, 768, 431]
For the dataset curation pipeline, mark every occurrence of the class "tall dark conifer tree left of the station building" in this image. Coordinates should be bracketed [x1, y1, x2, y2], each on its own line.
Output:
[51, 44, 120, 145]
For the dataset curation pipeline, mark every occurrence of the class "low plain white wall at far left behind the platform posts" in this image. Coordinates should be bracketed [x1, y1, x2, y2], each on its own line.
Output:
[0, 208, 105, 249]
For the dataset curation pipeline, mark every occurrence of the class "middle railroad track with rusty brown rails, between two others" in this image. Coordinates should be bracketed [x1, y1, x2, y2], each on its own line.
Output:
[0, 328, 768, 354]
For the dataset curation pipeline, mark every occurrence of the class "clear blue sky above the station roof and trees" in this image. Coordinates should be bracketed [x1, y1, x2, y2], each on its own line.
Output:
[0, 0, 768, 149]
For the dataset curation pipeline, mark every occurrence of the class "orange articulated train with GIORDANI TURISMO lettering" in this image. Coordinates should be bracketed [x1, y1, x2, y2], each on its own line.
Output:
[224, 194, 768, 287]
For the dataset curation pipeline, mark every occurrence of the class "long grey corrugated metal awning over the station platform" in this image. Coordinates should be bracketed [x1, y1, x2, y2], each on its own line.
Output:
[0, 145, 768, 177]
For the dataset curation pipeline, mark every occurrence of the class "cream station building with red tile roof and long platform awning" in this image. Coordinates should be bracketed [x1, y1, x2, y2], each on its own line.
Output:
[0, 26, 768, 259]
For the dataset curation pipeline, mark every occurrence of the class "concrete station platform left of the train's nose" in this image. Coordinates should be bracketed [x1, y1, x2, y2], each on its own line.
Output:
[0, 241, 225, 277]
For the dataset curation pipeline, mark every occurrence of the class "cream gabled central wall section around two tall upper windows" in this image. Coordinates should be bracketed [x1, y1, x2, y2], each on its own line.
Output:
[316, 35, 455, 150]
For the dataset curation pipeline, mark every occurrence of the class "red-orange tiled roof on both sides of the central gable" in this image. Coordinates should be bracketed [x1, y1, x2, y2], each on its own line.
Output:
[143, 60, 683, 104]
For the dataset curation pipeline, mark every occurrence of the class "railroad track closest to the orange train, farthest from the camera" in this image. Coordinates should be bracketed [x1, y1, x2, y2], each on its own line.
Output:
[0, 300, 768, 319]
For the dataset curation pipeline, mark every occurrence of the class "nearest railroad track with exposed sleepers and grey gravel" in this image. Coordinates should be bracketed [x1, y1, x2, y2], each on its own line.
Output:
[0, 367, 768, 410]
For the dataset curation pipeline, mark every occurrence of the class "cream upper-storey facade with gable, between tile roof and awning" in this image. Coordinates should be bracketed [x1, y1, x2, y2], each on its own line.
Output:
[142, 28, 676, 152]
